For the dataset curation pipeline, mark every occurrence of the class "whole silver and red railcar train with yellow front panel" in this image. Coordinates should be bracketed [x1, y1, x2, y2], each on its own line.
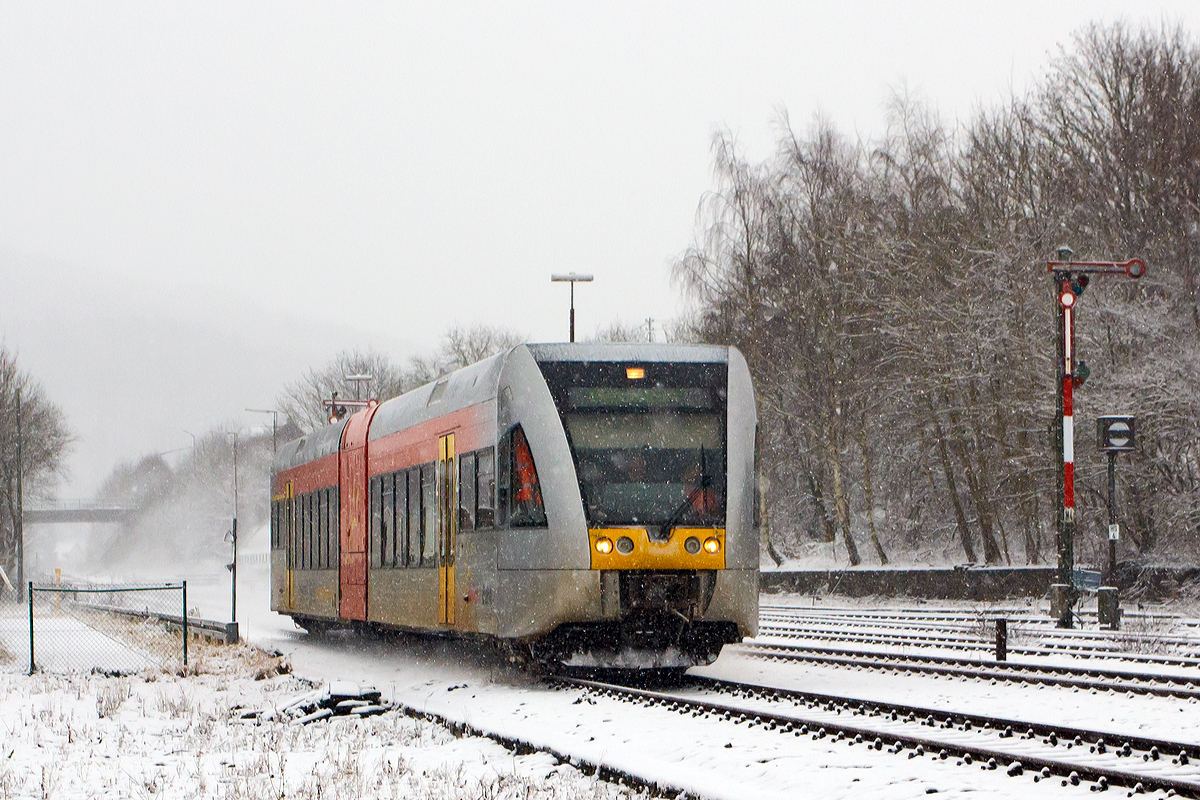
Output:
[270, 343, 761, 669]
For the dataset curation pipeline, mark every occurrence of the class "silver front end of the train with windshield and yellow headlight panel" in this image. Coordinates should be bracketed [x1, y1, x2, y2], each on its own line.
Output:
[502, 344, 758, 668]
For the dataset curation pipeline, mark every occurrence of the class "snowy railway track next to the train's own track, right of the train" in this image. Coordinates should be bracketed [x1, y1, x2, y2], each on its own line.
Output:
[740, 642, 1200, 699]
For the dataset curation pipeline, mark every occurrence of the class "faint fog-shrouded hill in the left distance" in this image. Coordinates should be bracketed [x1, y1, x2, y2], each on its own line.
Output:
[0, 248, 415, 497]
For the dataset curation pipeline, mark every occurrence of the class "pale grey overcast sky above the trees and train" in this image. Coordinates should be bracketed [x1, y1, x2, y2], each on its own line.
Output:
[0, 0, 1200, 489]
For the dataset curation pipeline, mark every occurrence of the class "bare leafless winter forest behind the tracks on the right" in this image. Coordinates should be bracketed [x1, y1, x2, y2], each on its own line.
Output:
[673, 24, 1200, 565]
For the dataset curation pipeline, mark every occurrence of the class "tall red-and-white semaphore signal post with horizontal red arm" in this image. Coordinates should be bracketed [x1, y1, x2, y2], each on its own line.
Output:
[1046, 246, 1146, 627]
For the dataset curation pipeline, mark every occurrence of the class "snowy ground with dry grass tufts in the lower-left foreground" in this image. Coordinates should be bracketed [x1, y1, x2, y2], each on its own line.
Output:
[0, 645, 629, 800]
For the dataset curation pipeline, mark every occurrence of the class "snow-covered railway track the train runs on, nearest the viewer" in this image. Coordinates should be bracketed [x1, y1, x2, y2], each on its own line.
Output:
[557, 678, 1200, 798]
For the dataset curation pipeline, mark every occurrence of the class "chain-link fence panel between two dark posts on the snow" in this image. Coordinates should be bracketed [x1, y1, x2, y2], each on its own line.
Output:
[29, 582, 187, 674]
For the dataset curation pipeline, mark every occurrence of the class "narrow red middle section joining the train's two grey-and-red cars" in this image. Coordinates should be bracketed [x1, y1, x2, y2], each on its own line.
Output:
[337, 403, 379, 620]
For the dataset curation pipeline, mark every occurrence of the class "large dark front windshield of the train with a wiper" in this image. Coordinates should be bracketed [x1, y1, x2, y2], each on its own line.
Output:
[540, 361, 726, 530]
